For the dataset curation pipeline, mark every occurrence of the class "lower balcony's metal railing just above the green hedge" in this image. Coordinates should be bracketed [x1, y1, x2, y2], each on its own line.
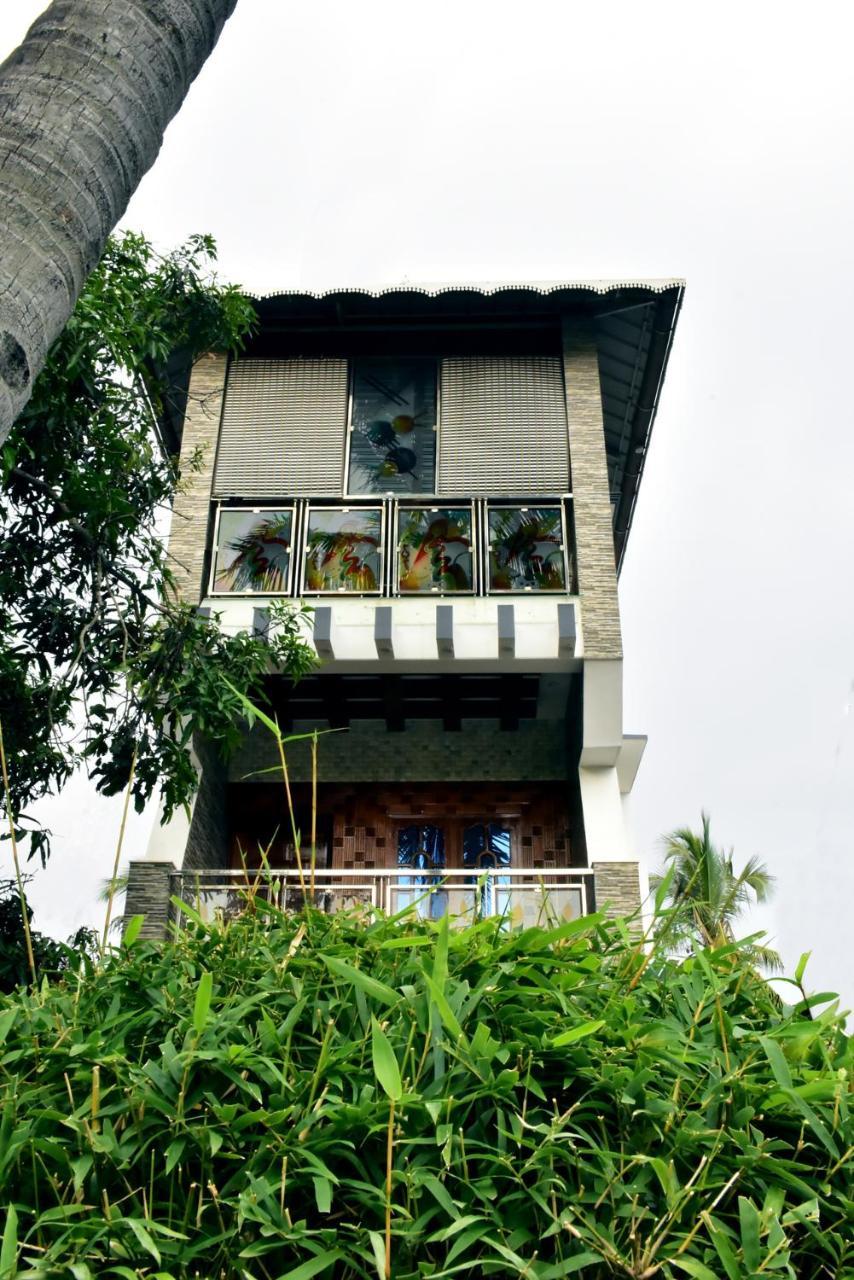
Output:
[172, 867, 593, 928]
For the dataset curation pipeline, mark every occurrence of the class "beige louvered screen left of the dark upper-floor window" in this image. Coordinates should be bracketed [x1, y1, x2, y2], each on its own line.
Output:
[214, 360, 348, 498]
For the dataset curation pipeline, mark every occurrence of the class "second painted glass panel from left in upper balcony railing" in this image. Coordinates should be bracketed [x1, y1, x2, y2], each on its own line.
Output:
[305, 507, 383, 591]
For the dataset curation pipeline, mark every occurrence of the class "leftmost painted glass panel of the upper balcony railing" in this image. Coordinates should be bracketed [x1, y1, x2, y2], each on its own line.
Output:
[213, 509, 293, 594]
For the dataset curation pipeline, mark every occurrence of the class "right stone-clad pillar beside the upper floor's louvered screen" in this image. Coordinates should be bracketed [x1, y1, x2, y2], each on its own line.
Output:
[563, 321, 622, 658]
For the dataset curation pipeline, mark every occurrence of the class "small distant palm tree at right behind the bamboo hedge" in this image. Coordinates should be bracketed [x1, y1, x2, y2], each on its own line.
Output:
[659, 813, 780, 969]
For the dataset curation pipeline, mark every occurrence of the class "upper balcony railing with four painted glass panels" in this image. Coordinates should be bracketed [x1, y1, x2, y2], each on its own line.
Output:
[210, 495, 574, 596]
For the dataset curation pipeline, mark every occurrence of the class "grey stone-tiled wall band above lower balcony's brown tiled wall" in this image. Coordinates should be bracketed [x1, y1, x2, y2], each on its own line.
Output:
[228, 721, 570, 782]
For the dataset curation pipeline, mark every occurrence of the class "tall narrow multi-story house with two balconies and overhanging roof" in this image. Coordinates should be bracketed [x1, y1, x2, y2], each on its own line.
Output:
[128, 280, 682, 932]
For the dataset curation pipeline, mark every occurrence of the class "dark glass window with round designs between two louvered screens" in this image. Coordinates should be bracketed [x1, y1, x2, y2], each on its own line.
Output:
[347, 360, 435, 494]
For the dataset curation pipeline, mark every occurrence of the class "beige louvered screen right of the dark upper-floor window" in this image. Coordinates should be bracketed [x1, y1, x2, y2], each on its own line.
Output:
[438, 356, 570, 495]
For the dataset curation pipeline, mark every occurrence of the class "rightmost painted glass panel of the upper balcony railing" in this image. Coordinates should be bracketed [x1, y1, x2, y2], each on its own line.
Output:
[489, 507, 566, 591]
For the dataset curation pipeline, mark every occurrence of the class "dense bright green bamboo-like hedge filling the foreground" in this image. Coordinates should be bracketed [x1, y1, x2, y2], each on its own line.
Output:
[0, 896, 854, 1280]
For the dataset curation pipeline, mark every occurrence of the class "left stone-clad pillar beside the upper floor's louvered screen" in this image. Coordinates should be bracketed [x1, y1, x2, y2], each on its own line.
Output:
[169, 353, 227, 604]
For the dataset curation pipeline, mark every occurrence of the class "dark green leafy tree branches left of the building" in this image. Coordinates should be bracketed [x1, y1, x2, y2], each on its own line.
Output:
[0, 233, 317, 858]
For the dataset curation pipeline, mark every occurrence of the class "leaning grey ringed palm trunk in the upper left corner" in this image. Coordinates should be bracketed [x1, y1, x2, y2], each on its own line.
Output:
[0, 0, 237, 444]
